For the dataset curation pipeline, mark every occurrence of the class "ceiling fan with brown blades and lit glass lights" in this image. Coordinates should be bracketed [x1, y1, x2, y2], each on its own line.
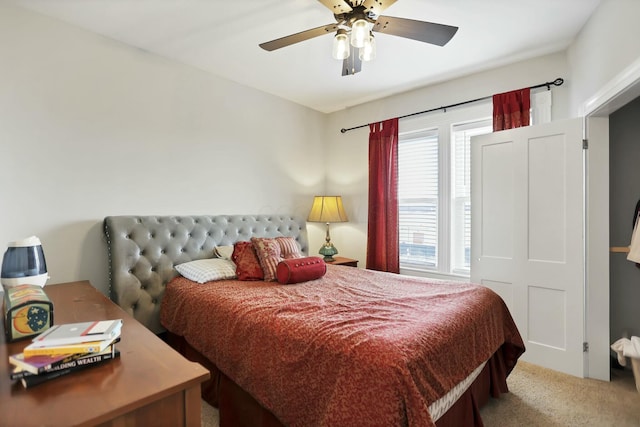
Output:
[259, 0, 458, 76]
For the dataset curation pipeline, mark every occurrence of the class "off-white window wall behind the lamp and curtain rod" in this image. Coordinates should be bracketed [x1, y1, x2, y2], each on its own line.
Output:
[324, 53, 571, 267]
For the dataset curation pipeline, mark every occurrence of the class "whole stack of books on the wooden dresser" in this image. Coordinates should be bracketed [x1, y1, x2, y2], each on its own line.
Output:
[9, 319, 122, 388]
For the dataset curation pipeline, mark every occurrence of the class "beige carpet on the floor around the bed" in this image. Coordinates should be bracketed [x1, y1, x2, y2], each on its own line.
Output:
[202, 362, 640, 427]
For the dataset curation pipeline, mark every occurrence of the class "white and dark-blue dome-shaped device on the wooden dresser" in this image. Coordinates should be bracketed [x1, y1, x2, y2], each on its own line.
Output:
[0, 236, 49, 287]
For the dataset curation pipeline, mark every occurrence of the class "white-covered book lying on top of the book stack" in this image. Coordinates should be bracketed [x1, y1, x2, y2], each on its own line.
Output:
[32, 319, 122, 347]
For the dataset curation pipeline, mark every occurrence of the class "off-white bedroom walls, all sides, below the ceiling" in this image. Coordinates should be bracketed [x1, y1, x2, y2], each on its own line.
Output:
[6, 0, 640, 298]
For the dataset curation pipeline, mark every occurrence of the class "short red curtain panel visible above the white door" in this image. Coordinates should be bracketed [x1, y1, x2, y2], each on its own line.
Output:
[493, 88, 531, 132]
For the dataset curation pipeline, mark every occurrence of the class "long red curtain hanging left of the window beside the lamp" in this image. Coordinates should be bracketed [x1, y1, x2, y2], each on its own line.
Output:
[367, 118, 400, 273]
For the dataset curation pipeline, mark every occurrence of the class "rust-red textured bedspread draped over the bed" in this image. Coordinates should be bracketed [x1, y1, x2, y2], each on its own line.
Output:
[161, 265, 524, 427]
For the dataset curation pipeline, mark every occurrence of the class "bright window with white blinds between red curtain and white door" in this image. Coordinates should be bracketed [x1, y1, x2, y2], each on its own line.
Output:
[398, 106, 492, 276]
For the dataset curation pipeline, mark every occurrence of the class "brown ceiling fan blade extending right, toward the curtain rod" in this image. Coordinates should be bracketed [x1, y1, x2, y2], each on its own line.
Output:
[373, 16, 458, 46]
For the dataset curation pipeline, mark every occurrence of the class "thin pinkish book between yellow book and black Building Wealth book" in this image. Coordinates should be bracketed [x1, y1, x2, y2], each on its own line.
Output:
[9, 343, 115, 380]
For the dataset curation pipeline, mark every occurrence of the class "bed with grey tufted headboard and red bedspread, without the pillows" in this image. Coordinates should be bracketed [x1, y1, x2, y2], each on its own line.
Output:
[104, 215, 524, 427]
